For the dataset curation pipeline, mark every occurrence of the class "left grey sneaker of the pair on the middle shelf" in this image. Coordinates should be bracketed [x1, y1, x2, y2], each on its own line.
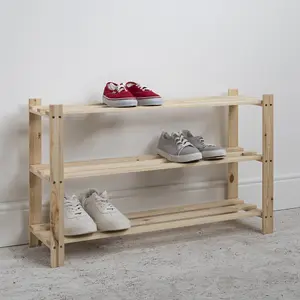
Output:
[157, 132, 202, 163]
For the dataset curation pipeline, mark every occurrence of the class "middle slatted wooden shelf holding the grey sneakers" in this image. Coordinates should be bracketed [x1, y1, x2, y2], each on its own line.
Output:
[30, 148, 262, 181]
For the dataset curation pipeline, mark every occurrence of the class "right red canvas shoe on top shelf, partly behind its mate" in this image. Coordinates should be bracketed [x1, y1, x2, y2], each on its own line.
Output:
[126, 81, 163, 105]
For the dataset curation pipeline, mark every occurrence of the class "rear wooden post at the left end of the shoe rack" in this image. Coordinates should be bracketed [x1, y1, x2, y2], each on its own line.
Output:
[28, 99, 42, 247]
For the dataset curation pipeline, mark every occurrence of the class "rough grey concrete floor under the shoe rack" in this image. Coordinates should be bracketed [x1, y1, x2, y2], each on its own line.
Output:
[0, 209, 300, 300]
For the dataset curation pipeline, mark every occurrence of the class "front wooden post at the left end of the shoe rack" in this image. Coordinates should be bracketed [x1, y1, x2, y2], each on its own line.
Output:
[49, 105, 65, 268]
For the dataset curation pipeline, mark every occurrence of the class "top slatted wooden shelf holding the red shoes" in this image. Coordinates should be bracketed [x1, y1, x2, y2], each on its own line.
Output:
[30, 96, 262, 116]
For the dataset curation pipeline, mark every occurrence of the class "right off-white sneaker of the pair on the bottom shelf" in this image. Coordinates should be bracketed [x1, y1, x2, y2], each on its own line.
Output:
[79, 189, 131, 232]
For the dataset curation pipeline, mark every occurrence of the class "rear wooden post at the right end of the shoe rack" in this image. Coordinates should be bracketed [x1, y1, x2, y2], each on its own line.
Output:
[227, 89, 239, 199]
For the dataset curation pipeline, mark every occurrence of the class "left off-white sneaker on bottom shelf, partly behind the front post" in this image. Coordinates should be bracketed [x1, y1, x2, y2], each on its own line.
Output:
[64, 195, 97, 236]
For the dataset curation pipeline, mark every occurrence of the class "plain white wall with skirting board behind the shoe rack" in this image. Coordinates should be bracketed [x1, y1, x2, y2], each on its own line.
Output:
[0, 0, 300, 246]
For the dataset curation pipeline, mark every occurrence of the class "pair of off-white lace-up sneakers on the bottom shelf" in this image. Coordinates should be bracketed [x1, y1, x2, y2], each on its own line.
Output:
[64, 189, 131, 236]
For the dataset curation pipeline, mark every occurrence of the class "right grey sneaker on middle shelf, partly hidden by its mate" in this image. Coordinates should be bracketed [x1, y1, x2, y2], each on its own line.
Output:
[182, 130, 226, 159]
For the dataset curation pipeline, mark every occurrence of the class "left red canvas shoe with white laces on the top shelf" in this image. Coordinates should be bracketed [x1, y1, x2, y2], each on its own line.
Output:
[103, 82, 137, 107]
